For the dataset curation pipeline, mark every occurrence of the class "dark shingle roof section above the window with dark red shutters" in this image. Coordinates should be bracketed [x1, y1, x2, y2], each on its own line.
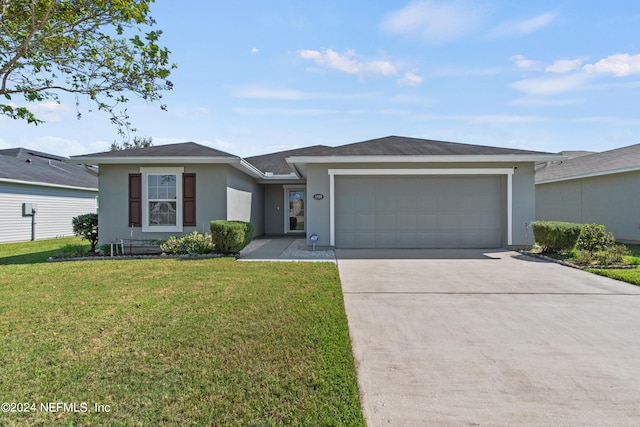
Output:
[74, 142, 238, 159]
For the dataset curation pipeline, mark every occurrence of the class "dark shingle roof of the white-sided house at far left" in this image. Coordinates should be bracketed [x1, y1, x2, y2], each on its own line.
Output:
[0, 148, 98, 188]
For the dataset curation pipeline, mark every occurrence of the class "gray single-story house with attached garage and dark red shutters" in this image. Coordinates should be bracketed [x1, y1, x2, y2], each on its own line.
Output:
[70, 136, 565, 248]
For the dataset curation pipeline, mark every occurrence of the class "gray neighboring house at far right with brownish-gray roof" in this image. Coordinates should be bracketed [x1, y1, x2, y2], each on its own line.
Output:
[536, 144, 640, 243]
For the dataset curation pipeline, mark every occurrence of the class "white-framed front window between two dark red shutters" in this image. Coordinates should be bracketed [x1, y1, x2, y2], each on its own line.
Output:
[140, 168, 184, 232]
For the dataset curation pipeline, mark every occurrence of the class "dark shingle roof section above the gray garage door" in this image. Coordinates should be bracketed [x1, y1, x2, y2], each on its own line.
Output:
[304, 136, 549, 156]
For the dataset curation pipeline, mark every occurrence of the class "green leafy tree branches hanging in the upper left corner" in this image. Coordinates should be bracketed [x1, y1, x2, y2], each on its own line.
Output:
[0, 0, 176, 133]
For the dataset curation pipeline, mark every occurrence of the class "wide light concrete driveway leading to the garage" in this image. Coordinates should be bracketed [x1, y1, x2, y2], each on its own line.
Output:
[336, 250, 640, 426]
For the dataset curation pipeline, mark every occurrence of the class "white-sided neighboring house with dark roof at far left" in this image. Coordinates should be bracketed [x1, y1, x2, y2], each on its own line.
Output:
[0, 148, 98, 243]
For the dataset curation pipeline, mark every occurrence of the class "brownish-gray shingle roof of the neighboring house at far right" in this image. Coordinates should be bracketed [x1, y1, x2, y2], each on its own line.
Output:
[536, 144, 640, 183]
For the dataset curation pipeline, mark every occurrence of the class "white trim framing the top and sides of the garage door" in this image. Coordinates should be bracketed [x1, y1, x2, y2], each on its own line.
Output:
[328, 168, 514, 246]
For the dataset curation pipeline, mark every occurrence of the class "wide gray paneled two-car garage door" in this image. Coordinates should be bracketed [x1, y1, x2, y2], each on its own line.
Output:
[335, 176, 506, 248]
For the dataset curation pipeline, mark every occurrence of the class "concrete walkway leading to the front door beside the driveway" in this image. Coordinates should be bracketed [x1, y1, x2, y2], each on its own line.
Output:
[238, 236, 336, 262]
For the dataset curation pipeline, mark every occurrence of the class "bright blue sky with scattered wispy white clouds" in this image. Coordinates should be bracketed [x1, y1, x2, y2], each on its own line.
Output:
[0, 0, 640, 156]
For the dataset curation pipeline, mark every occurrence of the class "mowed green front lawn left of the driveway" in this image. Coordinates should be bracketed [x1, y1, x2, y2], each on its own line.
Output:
[0, 242, 364, 426]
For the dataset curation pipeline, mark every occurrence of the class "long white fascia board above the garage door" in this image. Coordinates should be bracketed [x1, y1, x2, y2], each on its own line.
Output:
[285, 154, 567, 164]
